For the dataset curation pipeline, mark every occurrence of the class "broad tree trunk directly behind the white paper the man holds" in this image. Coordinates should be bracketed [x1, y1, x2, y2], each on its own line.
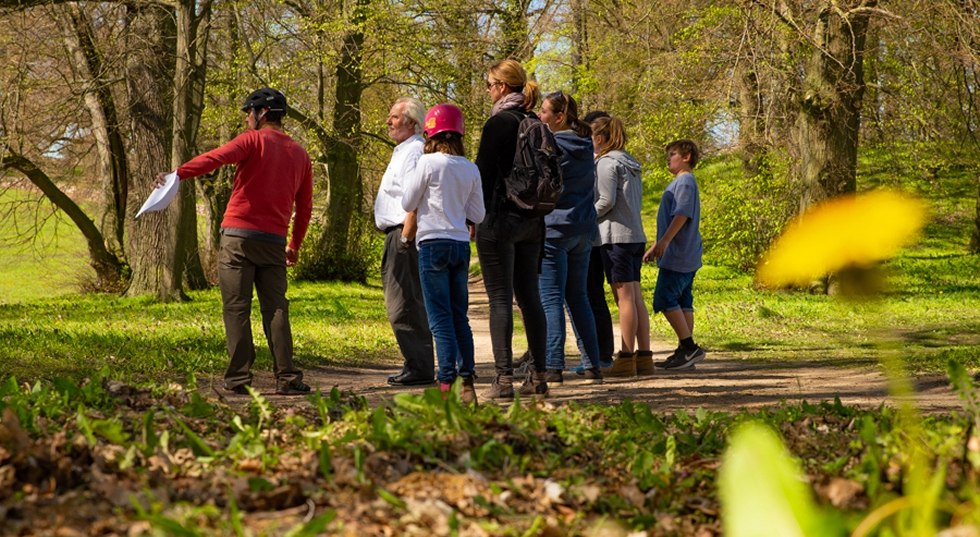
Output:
[125, 4, 189, 301]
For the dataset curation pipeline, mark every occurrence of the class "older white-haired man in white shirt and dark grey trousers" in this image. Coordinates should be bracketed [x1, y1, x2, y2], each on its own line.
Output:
[374, 97, 435, 386]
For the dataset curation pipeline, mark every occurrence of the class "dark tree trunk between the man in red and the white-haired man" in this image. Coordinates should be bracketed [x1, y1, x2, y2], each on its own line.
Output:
[297, 0, 370, 282]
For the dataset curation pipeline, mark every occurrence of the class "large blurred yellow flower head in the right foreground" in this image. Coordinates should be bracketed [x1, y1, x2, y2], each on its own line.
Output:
[756, 190, 926, 287]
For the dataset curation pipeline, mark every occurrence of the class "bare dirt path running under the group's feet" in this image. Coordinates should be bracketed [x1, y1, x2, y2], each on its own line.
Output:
[229, 281, 962, 412]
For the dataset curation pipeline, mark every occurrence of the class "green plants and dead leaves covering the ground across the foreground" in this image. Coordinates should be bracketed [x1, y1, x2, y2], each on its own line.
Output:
[7, 379, 980, 536]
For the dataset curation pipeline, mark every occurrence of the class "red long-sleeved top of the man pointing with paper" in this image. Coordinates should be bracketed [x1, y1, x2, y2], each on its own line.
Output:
[177, 128, 313, 250]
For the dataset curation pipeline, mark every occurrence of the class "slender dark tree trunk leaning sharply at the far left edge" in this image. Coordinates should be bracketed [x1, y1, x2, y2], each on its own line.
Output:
[0, 149, 123, 290]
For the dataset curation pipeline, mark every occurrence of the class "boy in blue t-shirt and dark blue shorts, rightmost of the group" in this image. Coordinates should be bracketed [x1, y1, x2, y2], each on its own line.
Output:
[643, 140, 704, 369]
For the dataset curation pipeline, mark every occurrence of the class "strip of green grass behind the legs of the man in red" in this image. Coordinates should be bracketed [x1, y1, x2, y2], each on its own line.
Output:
[0, 283, 399, 380]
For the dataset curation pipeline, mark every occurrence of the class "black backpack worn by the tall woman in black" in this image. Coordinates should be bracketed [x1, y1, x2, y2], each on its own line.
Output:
[504, 110, 562, 216]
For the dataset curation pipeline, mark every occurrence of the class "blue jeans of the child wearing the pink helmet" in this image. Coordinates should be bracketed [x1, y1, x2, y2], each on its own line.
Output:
[419, 239, 475, 384]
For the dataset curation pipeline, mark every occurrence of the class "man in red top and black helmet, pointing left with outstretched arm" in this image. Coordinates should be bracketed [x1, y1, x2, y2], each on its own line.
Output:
[157, 88, 313, 395]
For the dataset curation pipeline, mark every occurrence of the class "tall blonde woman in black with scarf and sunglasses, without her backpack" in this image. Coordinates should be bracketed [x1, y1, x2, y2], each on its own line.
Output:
[476, 59, 548, 399]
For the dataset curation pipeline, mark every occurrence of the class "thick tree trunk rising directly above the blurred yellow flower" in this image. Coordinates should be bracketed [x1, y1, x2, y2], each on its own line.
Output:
[795, 0, 877, 208]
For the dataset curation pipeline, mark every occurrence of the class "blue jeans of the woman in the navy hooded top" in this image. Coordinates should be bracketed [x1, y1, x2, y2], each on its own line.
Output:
[540, 235, 599, 370]
